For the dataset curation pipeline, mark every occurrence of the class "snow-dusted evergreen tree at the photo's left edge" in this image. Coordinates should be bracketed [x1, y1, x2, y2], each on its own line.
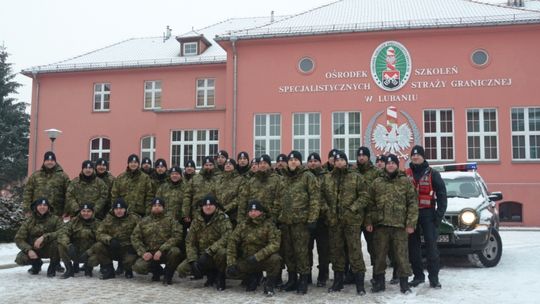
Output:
[0, 46, 30, 188]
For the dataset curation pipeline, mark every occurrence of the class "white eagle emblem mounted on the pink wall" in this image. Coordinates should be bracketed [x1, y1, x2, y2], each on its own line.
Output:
[372, 124, 412, 154]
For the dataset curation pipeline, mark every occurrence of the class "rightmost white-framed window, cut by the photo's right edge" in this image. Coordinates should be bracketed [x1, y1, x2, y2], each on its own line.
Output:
[512, 108, 540, 160]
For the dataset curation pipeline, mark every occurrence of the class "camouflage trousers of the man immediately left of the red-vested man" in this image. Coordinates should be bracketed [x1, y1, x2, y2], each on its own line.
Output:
[373, 226, 412, 277]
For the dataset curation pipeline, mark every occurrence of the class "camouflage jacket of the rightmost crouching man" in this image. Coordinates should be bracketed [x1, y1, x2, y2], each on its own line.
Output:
[227, 214, 281, 266]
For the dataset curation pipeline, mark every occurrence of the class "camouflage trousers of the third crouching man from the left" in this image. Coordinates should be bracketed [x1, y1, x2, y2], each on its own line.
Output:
[87, 242, 137, 270]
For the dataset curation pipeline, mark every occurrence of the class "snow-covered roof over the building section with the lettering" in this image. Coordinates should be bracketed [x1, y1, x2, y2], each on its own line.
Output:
[218, 0, 540, 40]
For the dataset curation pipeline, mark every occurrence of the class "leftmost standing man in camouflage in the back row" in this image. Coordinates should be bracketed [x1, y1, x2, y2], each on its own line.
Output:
[23, 151, 69, 217]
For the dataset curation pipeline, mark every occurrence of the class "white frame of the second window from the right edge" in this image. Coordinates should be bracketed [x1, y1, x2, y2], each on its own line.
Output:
[465, 108, 499, 161]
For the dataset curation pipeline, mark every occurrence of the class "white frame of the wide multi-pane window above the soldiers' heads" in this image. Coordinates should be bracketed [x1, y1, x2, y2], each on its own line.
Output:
[170, 129, 220, 168]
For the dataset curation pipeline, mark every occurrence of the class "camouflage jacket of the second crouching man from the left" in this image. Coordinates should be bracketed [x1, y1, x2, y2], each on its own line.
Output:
[58, 215, 99, 251]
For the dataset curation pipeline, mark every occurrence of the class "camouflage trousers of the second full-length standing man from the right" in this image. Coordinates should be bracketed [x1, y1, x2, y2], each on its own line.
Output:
[330, 223, 366, 273]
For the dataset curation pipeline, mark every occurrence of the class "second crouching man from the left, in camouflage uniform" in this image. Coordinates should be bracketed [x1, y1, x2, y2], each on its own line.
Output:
[58, 203, 99, 279]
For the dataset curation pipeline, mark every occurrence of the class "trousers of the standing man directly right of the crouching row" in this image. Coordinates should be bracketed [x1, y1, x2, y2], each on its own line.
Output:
[281, 223, 313, 274]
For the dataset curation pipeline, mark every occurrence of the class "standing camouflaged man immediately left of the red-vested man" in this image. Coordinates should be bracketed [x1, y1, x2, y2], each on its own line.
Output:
[365, 154, 418, 293]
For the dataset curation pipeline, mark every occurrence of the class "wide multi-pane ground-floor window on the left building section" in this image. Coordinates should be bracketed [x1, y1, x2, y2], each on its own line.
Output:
[171, 130, 219, 167]
